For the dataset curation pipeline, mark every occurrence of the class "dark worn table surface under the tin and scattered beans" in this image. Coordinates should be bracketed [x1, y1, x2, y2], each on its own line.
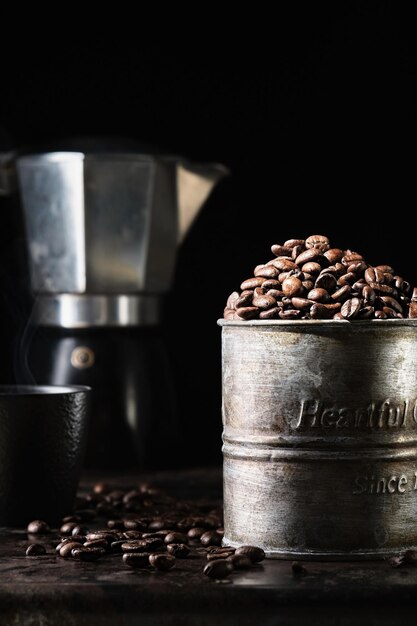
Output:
[0, 469, 417, 626]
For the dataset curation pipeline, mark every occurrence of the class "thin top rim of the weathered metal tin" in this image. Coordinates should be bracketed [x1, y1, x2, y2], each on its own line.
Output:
[217, 318, 417, 328]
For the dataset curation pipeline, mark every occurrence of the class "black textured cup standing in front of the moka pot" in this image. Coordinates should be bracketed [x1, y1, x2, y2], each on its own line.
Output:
[0, 385, 90, 527]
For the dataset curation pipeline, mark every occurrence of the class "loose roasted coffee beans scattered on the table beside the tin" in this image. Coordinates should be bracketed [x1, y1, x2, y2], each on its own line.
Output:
[26, 482, 265, 579]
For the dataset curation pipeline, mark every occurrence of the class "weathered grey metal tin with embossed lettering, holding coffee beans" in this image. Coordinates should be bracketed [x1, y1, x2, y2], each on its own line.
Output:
[219, 320, 417, 560]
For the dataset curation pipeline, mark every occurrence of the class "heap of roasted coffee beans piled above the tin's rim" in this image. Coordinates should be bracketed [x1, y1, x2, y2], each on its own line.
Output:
[224, 235, 417, 320]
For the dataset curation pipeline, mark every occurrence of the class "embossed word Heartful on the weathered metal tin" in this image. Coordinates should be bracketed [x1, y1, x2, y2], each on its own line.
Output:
[290, 398, 417, 430]
